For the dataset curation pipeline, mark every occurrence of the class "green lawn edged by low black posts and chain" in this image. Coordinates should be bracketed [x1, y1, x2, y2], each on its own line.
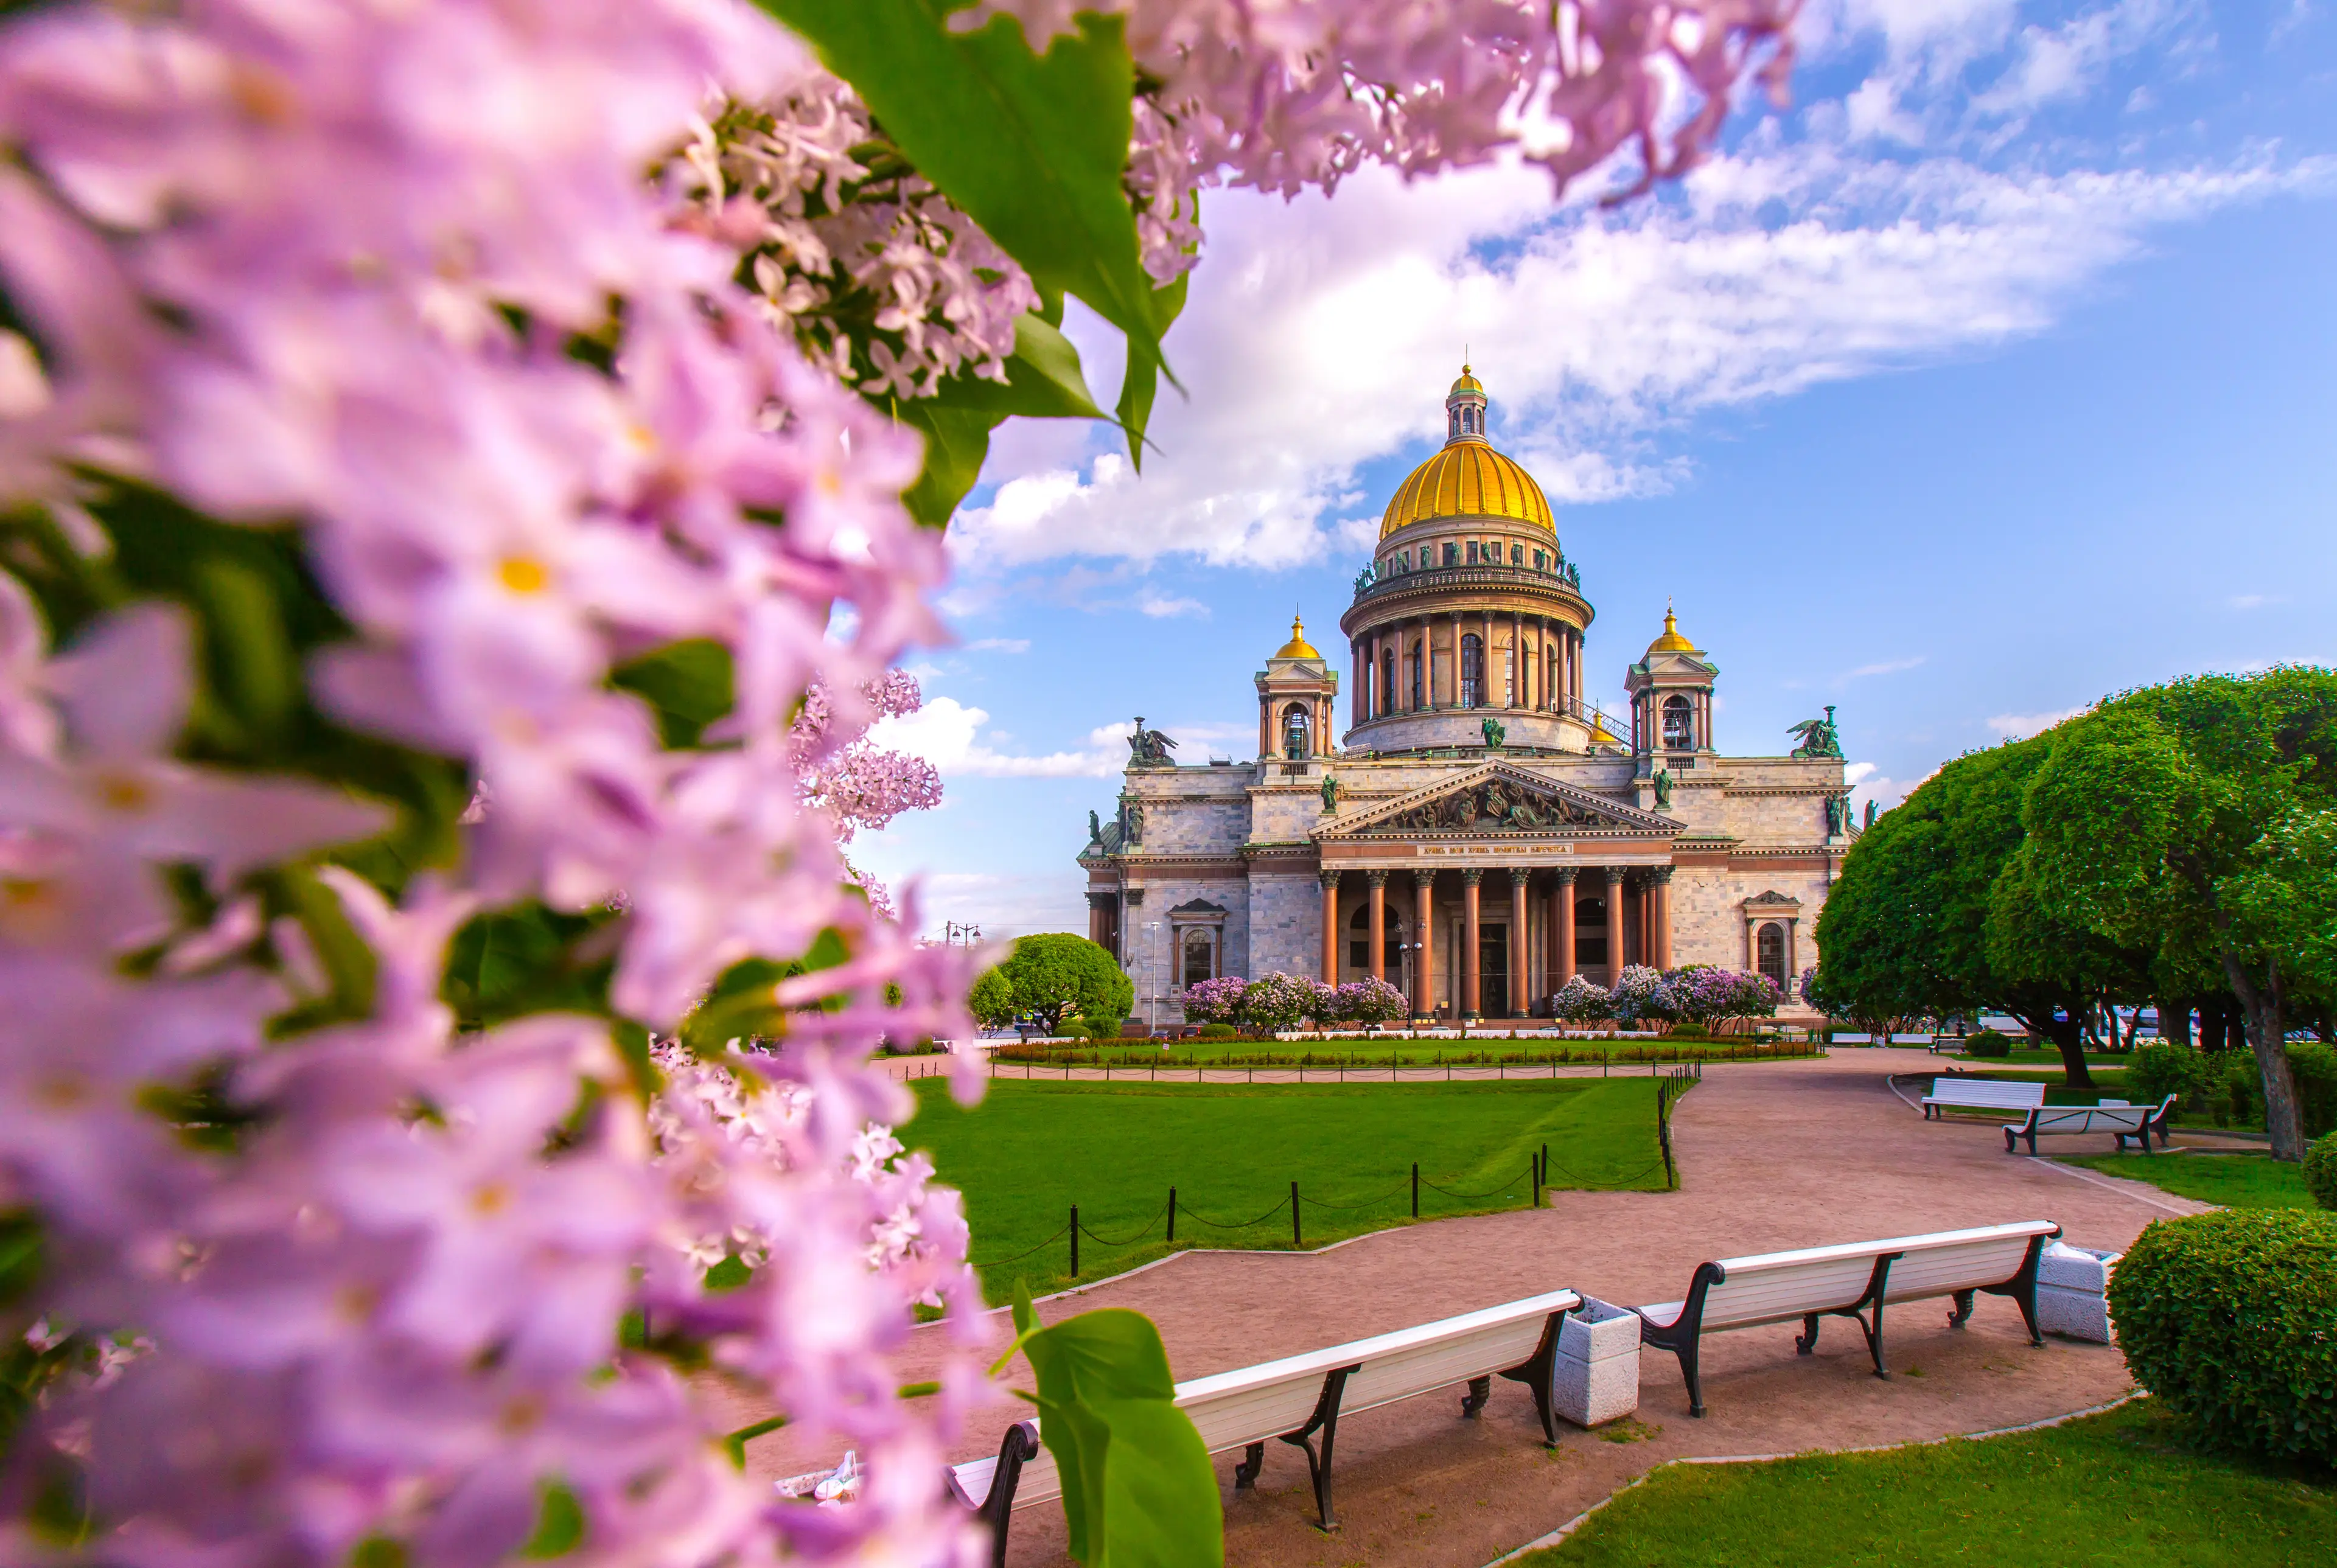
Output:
[900, 1077, 1664, 1301]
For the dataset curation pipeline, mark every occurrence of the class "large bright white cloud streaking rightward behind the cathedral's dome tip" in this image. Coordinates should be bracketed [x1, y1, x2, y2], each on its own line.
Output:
[951, 138, 2328, 570]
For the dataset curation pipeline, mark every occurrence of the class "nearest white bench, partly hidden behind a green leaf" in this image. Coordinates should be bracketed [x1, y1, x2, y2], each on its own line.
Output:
[949, 1290, 1582, 1566]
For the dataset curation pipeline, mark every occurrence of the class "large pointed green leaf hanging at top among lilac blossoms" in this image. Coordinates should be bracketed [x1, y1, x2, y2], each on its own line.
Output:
[762, 0, 1159, 395]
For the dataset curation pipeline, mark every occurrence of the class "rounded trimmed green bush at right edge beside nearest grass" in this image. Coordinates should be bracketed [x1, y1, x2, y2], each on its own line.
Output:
[2111, 1208, 2337, 1465]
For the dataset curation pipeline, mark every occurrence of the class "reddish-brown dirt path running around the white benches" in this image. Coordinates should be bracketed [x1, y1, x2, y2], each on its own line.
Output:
[719, 1049, 2204, 1568]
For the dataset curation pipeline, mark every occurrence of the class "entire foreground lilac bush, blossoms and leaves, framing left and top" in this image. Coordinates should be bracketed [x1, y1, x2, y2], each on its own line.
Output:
[0, 0, 1790, 1568]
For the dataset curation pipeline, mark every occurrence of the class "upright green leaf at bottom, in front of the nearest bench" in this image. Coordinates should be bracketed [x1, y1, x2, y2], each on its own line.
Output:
[1015, 1295, 1224, 1568]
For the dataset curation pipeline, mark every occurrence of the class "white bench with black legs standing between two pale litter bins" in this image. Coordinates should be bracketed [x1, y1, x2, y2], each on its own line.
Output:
[1633, 1220, 2061, 1416]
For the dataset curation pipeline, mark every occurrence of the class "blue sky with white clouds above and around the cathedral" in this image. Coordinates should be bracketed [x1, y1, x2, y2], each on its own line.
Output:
[855, 0, 2337, 935]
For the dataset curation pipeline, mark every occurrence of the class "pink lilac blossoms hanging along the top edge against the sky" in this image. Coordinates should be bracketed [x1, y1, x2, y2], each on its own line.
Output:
[958, 0, 1800, 280]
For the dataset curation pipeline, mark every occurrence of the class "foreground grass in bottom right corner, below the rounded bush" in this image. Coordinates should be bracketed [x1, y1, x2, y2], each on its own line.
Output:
[1519, 1399, 2337, 1568]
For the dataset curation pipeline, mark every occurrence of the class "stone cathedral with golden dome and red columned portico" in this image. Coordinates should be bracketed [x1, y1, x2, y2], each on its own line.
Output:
[1080, 367, 1856, 1021]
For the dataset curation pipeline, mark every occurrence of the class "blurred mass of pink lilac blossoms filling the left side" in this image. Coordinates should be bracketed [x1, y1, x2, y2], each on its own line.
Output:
[0, 0, 982, 1566]
